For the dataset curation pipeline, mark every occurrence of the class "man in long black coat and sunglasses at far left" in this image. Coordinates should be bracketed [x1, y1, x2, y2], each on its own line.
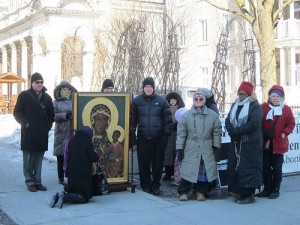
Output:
[13, 73, 55, 192]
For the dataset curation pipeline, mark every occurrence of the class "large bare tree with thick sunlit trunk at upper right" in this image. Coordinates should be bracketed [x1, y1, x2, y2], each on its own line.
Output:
[205, 0, 294, 100]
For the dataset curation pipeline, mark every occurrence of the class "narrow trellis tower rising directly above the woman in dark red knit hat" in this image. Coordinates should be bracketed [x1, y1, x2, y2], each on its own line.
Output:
[243, 38, 256, 86]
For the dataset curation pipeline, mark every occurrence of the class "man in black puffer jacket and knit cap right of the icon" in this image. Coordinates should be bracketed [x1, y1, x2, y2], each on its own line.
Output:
[132, 77, 172, 195]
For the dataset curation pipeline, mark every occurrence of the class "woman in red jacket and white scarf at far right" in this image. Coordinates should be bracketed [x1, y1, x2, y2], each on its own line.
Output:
[257, 85, 295, 199]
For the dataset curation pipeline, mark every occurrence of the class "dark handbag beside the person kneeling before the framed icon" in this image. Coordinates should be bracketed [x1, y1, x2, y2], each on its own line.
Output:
[93, 162, 111, 196]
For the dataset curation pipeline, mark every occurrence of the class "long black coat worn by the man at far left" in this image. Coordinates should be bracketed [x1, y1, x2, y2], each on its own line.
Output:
[13, 87, 54, 152]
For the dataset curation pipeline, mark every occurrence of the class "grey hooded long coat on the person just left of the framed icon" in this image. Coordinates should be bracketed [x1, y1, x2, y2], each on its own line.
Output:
[53, 81, 76, 156]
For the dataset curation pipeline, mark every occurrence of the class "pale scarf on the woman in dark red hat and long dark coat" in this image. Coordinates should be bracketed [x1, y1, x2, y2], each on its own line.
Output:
[230, 96, 250, 128]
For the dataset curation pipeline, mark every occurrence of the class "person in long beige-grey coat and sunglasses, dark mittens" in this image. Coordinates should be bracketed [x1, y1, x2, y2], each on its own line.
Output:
[176, 91, 222, 201]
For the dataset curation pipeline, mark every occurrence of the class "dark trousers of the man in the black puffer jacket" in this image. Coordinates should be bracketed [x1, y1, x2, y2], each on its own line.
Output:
[137, 140, 165, 189]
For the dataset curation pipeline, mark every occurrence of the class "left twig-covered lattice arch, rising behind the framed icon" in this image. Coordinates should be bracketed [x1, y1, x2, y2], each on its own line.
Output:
[111, 22, 145, 93]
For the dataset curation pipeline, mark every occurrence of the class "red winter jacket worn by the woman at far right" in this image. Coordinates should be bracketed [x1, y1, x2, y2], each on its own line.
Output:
[262, 103, 295, 154]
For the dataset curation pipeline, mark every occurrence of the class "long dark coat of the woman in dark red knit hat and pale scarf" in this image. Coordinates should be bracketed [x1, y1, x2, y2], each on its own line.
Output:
[225, 94, 263, 188]
